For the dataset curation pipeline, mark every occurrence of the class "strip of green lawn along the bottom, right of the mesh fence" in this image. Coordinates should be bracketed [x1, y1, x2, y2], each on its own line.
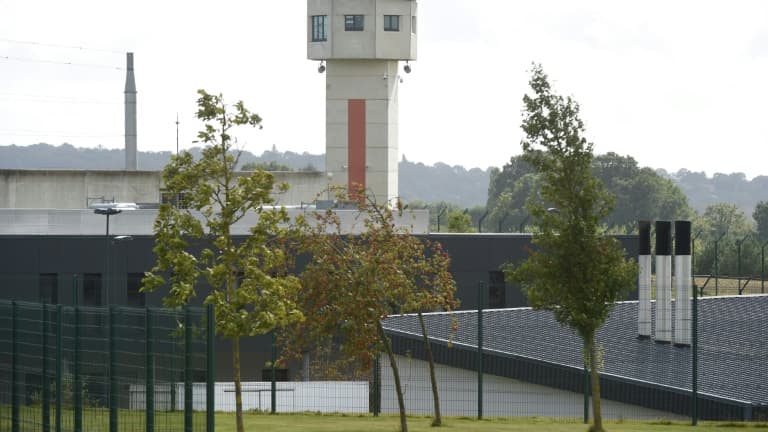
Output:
[231, 413, 768, 432]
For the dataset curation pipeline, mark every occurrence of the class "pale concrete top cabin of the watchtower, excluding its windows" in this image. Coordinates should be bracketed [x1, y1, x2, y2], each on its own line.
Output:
[307, 0, 417, 60]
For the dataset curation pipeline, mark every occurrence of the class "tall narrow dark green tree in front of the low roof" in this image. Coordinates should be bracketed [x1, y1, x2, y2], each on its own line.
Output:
[505, 65, 637, 431]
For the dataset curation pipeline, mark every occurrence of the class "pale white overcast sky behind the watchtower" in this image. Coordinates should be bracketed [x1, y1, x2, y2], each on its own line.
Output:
[0, 0, 768, 178]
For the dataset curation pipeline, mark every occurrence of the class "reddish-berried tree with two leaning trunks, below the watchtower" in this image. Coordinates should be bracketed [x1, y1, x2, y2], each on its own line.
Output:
[284, 192, 458, 432]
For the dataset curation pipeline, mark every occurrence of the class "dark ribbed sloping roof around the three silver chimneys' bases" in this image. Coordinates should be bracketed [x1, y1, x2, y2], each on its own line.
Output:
[384, 295, 768, 405]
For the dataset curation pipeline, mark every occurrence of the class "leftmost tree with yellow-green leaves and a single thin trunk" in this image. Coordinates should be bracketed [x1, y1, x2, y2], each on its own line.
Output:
[142, 90, 301, 432]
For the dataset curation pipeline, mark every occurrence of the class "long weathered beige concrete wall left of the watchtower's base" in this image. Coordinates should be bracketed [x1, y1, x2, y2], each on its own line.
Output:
[0, 170, 328, 209]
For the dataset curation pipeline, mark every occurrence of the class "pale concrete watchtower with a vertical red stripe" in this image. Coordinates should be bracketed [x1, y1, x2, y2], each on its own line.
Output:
[307, 0, 417, 203]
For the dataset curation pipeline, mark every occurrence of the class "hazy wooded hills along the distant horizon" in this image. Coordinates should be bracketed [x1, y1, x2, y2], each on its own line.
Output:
[0, 144, 768, 213]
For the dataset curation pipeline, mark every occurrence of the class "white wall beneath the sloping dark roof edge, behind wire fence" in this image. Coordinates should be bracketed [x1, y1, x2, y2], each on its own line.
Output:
[381, 355, 688, 420]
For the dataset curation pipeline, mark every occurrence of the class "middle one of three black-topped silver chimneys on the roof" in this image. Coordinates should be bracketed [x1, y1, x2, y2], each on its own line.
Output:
[654, 221, 672, 343]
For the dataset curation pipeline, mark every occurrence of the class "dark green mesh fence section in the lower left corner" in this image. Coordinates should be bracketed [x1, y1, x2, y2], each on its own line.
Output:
[0, 301, 214, 432]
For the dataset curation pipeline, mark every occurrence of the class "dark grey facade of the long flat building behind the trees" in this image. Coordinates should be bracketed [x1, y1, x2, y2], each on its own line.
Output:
[0, 234, 638, 380]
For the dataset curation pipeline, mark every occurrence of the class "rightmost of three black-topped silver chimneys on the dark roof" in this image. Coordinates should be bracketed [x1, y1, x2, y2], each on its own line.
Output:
[672, 221, 693, 346]
